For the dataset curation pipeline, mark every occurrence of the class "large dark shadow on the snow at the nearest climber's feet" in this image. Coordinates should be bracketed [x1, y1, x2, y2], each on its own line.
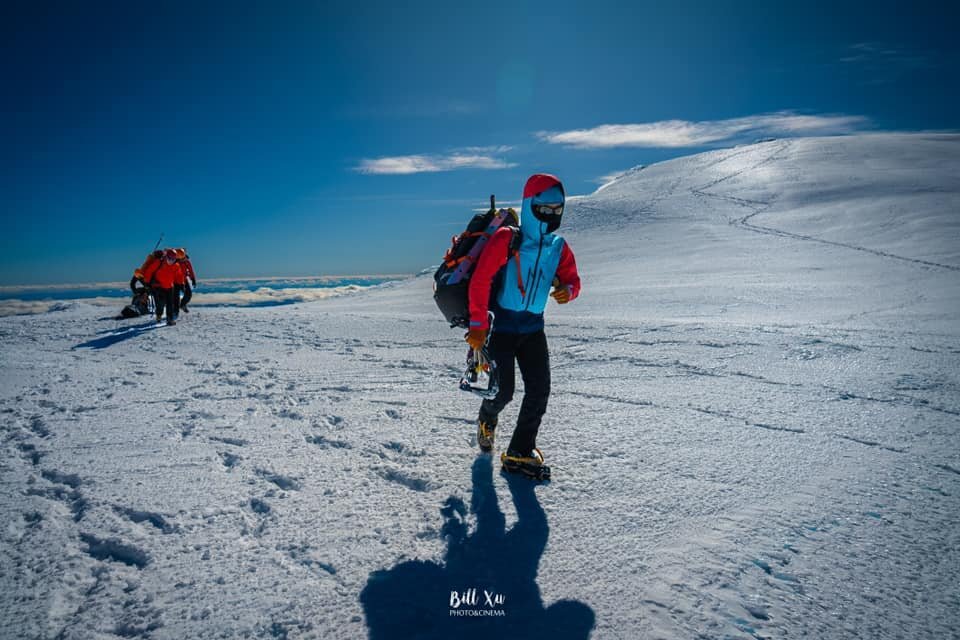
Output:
[360, 456, 595, 640]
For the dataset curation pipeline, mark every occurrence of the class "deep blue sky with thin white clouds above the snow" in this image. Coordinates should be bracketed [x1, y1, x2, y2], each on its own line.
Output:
[0, 0, 960, 285]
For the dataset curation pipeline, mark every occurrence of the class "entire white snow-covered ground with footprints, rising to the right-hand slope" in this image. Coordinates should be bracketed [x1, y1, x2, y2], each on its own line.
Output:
[0, 134, 960, 640]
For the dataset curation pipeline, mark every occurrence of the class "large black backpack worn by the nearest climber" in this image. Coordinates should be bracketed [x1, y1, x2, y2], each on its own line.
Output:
[433, 196, 520, 329]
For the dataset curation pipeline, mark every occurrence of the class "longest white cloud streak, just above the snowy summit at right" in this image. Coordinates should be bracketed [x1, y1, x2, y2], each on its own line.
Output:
[537, 111, 869, 149]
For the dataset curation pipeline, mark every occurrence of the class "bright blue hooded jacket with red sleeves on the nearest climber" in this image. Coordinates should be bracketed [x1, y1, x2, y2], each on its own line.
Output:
[469, 174, 580, 333]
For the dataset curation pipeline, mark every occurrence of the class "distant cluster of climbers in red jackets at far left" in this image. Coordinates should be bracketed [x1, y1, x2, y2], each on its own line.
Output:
[122, 248, 197, 325]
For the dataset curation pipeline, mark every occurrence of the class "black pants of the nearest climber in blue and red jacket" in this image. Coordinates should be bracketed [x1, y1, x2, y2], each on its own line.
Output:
[480, 329, 550, 455]
